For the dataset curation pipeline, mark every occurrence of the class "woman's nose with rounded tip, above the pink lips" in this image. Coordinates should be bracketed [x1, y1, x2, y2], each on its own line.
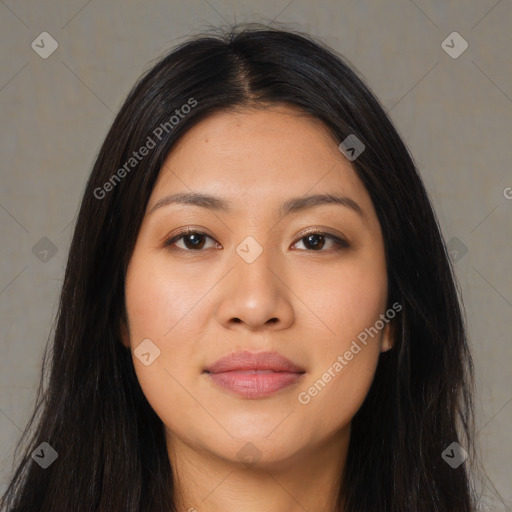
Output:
[216, 245, 295, 331]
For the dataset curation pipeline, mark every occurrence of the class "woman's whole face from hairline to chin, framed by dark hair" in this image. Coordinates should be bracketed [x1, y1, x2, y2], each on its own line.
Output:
[123, 106, 391, 467]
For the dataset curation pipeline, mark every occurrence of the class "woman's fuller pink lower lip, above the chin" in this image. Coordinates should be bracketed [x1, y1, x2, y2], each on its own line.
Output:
[207, 371, 303, 398]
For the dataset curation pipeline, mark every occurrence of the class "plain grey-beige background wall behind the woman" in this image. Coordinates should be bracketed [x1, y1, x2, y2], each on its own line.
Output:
[0, 0, 512, 510]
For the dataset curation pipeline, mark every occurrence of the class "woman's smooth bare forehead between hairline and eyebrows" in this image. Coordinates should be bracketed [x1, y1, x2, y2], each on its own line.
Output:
[149, 105, 371, 218]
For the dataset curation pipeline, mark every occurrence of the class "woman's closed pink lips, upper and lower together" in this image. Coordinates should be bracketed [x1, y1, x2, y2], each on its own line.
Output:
[205, 351, 305, 399]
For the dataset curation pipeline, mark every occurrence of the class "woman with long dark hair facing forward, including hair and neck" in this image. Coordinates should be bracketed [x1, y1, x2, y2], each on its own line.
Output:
[3, 28, 475, 512]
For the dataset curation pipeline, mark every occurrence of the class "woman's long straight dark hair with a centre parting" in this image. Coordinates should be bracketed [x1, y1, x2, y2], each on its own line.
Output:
[1, 26, 475, 512]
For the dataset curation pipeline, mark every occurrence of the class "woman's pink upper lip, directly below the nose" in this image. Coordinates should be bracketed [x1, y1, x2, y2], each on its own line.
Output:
[205, 351, 305, 373]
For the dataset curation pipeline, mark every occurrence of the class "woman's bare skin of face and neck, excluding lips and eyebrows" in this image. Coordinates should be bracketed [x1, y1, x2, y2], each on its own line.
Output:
[122, 105, 392, 512]
